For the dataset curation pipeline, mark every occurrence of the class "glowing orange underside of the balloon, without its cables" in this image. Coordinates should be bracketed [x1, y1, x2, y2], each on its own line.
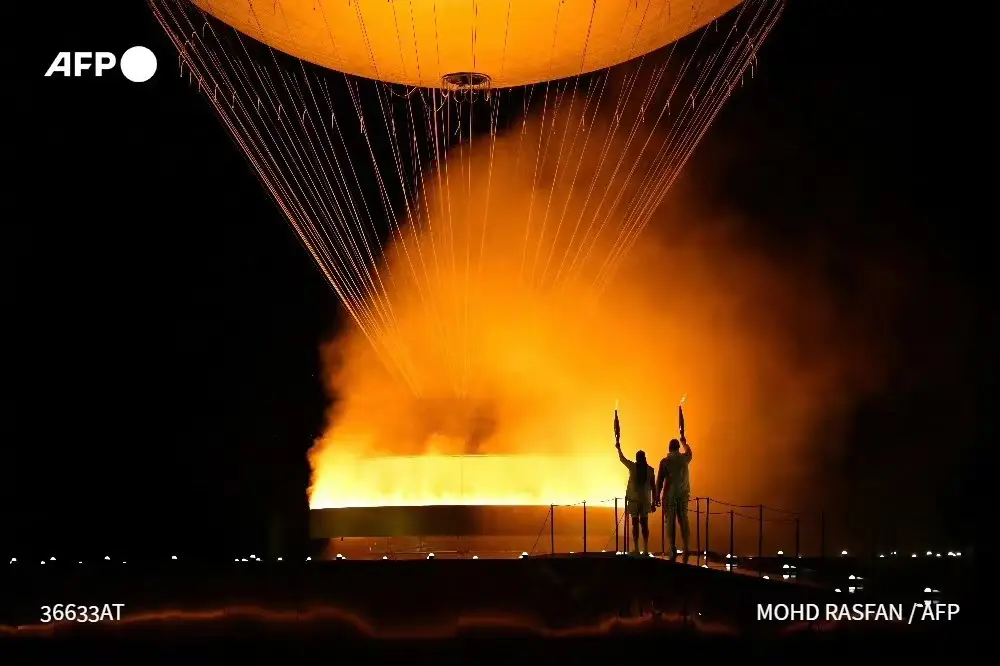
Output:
[192, 0, 740, 88]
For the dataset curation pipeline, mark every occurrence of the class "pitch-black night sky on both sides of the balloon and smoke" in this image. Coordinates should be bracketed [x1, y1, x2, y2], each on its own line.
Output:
[0, 0, 995, 557]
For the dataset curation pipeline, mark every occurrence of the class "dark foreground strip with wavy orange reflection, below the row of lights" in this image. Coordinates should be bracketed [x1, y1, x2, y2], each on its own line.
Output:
[0, 556, 974, 652]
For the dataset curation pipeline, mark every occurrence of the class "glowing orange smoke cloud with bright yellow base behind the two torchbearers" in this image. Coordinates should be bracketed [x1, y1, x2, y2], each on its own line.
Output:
[310, 98, 880, 508]
